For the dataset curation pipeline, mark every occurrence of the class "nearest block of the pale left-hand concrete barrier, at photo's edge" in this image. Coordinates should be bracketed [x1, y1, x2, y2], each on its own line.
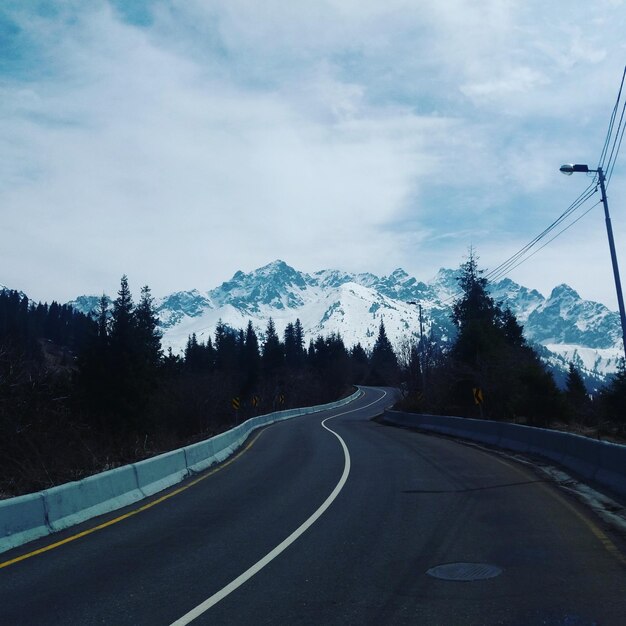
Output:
[0, 492, 50, 552]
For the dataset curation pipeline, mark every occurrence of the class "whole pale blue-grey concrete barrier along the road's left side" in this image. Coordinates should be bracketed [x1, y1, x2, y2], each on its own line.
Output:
[0, 391, 362, 553]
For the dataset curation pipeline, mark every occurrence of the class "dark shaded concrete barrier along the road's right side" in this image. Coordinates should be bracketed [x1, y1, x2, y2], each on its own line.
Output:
[384, 411, 626, 496]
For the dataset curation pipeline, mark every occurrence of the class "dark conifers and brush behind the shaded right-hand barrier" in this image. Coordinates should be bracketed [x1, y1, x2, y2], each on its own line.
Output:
[400, 250, 626, 441]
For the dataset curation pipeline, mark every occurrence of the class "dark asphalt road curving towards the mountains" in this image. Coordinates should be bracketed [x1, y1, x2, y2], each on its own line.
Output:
[0, 388, 626, 626]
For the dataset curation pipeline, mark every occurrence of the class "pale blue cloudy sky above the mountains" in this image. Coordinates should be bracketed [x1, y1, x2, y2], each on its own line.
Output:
[0, 0, 626, 310]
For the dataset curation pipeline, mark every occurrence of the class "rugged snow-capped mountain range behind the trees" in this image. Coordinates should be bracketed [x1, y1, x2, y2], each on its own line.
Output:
[66, 261, 622, 377]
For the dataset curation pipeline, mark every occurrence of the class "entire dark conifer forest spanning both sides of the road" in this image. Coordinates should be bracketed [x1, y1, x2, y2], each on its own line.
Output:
[0, 254, 626, 498]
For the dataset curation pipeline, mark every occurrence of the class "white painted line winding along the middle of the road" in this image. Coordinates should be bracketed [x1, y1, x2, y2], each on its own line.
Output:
[171, 391, 387, 626]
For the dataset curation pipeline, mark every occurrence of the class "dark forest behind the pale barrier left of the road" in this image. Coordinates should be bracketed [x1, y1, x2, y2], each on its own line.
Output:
[0, 276, 400, 497]
